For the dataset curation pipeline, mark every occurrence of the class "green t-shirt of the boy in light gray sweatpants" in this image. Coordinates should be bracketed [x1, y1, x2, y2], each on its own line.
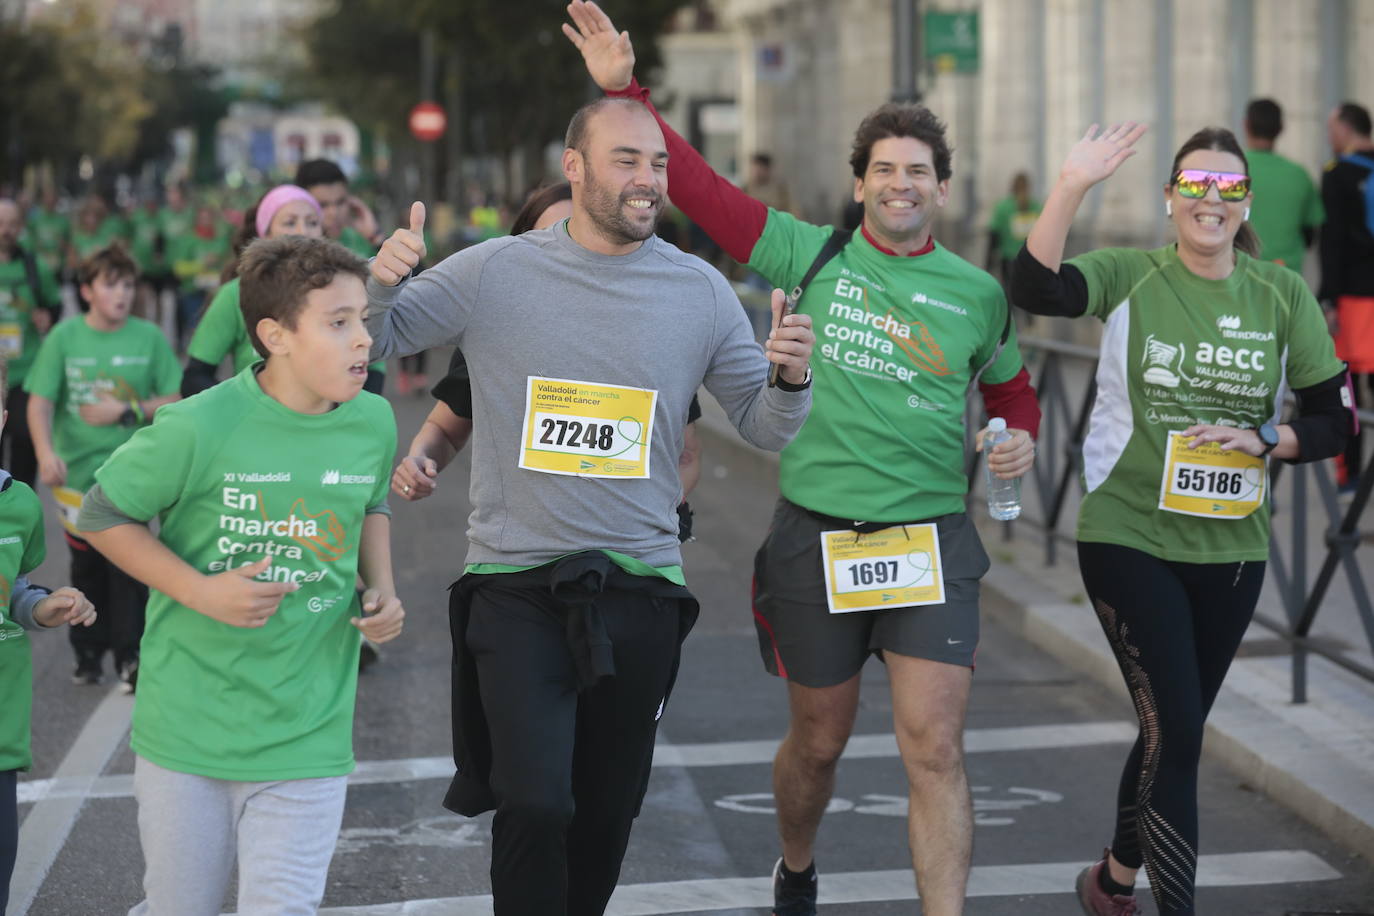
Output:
[96, 369, 396, 781]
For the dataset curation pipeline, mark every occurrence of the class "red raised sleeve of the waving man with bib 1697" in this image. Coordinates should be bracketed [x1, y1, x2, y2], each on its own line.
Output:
[606, 80, 768, 264]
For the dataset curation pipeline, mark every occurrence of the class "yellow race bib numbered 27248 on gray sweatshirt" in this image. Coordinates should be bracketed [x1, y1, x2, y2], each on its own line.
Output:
[519, 375, 658, 478]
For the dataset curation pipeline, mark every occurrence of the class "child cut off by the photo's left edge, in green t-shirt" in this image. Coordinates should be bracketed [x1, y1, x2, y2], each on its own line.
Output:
[0, 356, 95, 913]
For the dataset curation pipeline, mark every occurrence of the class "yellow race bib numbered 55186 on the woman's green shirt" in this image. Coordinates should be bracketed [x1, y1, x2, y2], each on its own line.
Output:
[1160, 431, 1268, 519]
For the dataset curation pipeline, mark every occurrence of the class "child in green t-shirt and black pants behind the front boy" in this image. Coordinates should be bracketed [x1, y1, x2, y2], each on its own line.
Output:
[23, 244, 180, 692]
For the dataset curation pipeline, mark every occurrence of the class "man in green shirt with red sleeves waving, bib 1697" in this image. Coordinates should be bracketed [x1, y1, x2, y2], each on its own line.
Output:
[563, 0, 1040, 916]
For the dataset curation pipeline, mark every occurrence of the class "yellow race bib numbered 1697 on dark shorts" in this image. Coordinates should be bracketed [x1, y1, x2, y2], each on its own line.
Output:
[820, 525, 944, 614]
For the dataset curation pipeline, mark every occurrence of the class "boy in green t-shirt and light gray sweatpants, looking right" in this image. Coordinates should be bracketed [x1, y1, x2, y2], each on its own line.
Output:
[78, 238, 404, 916]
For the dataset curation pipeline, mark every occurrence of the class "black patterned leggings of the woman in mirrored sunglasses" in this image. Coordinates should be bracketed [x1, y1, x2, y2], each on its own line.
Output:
[1079, 541, 1264, 915]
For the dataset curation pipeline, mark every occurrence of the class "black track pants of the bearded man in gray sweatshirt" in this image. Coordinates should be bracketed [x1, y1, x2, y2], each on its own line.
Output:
[466, 577, 680, 916]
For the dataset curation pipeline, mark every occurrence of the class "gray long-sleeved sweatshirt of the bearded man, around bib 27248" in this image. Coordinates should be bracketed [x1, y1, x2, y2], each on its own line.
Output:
[367, 221, 811, 567]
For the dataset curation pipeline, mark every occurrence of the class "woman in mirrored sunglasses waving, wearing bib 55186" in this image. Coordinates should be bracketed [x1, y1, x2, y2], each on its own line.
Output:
[1011, 124, 1353, 916]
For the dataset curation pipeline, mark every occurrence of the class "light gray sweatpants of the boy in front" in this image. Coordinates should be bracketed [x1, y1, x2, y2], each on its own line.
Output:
[129, 757, 348, 916]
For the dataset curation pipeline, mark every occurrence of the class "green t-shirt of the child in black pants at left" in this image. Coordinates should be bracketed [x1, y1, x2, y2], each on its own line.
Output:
[23, 316, 181, 494]
